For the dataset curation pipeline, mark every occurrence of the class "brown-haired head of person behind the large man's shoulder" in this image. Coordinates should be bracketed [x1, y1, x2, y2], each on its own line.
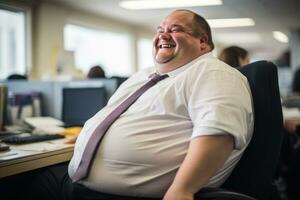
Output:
[219, 46, 249, 68]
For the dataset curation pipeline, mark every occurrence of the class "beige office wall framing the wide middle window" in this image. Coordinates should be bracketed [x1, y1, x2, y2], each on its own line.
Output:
[31, 2, 153, 79]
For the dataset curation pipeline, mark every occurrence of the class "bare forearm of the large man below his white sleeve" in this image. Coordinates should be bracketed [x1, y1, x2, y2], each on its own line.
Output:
[164, 135, 234, 200]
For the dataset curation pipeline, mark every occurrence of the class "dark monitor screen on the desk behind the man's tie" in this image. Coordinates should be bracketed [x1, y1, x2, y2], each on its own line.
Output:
[62, 87, 107, 126]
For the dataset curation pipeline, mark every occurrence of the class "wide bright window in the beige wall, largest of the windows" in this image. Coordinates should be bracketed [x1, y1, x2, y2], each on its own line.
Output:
[64, 24, 134, 76]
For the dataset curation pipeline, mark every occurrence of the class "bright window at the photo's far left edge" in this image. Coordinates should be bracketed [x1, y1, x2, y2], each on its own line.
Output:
[0, 9, 26, 79]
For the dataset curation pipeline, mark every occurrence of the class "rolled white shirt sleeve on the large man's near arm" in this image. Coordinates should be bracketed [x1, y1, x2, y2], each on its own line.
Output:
[188, 70, 253, 149]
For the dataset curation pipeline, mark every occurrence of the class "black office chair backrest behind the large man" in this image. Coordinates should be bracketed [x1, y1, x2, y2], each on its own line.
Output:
[222, 61, 283, 199]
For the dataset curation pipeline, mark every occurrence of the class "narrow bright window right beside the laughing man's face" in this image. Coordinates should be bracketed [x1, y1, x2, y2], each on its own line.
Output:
[138, 38, 153, 69]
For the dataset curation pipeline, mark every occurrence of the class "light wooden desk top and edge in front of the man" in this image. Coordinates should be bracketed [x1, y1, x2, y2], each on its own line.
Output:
[0, 139, 74, 178]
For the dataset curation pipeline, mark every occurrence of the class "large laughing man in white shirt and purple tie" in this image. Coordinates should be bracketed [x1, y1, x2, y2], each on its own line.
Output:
[28, 10, 254, 200]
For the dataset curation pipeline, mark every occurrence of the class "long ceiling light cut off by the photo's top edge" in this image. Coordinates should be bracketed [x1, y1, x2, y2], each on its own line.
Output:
[119, 0, 223, 10]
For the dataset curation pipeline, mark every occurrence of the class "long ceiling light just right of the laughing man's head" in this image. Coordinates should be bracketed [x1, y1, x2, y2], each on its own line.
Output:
[207, 18, 255, 28]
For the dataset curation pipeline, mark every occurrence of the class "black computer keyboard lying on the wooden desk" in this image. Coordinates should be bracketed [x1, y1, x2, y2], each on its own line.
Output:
[2, 134, 65, 144]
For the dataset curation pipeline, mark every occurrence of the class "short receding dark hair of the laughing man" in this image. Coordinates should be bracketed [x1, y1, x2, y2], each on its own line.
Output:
[175, 9, 215, 50]
